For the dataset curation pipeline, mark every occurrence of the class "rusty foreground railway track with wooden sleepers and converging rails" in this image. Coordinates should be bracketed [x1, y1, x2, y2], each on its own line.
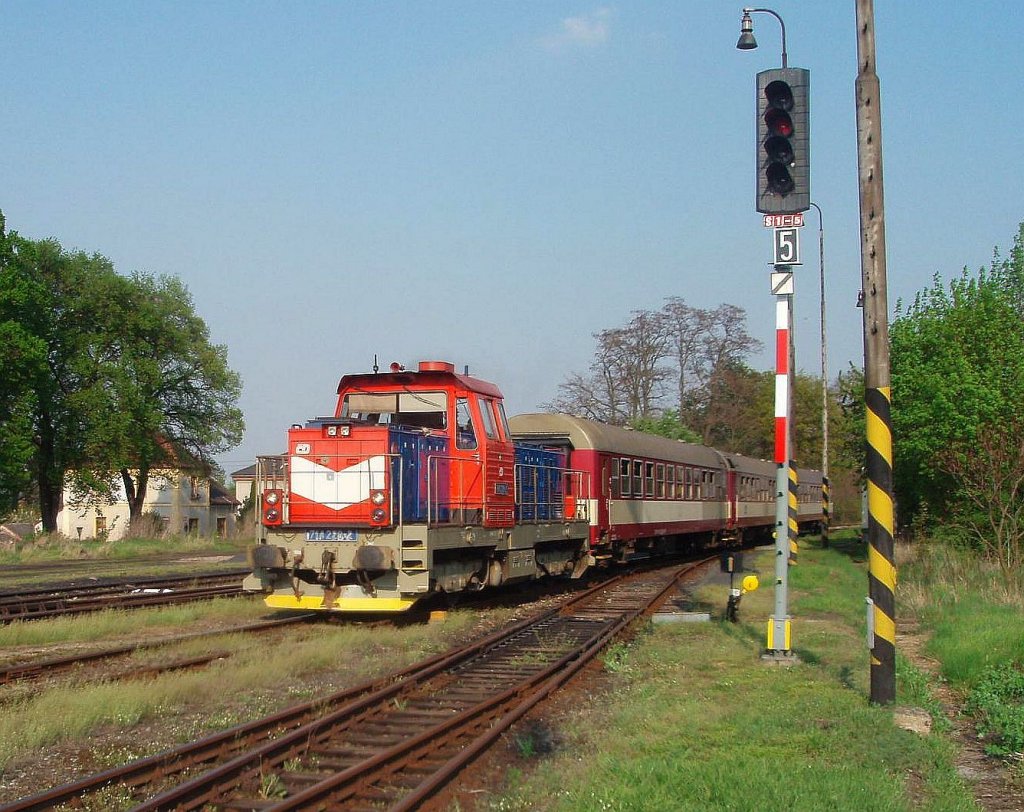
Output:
[0, 563, 699, 812]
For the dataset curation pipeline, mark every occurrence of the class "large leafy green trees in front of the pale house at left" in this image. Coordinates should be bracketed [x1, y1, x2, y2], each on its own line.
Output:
[0, 215, 243, 531]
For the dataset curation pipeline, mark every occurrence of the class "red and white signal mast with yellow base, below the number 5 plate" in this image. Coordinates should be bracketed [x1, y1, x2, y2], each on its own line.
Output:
[767, 265, 793, 656]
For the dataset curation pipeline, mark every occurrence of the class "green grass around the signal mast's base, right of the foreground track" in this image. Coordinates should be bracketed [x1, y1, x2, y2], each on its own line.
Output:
[490, 528, 977, 812]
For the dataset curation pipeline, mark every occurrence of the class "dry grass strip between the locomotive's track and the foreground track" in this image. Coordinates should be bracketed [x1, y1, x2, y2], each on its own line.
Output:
[0, 604, 485, 772]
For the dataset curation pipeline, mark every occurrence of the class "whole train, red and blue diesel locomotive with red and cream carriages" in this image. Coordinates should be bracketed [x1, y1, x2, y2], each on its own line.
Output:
[245, 361, 822, 612]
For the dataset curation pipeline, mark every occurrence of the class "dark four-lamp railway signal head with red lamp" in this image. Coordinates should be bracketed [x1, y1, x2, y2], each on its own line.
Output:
[757, 68, 811, 214]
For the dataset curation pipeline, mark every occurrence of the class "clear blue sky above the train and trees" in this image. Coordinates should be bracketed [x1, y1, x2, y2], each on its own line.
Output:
[0, 0, 1024, 472]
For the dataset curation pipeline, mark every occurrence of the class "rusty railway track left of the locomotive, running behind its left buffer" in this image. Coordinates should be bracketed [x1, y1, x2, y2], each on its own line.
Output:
[0, 569, 249, 623]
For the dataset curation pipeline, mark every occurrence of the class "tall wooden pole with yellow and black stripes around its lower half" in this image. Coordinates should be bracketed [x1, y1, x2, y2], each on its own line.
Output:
[856, 0, 896, 704]
